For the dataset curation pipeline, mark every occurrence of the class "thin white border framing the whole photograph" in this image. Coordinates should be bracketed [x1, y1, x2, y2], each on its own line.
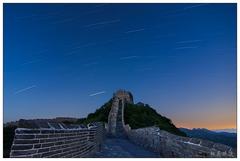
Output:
[0, 0, 240, 161]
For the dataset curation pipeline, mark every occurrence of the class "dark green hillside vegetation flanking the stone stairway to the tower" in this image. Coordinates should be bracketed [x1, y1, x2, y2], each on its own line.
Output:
[77, 99, 186, 136]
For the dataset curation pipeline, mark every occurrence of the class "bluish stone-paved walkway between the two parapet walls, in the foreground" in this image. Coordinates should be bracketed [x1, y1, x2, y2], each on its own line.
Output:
[94, 138, 159, 158]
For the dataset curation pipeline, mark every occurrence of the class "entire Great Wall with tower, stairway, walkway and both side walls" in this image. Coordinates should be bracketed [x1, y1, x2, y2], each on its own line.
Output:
[10, 90, 237, 158]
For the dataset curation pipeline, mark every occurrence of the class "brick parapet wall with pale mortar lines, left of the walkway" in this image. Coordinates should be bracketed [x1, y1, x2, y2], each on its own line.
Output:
[10, 123, 105, 158]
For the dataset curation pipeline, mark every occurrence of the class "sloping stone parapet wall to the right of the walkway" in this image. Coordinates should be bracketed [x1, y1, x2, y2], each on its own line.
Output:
[128, 127, 236, 158]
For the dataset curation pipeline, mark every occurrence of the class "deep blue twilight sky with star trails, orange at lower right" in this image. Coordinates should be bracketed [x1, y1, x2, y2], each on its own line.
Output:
[4, 4, 237, 129]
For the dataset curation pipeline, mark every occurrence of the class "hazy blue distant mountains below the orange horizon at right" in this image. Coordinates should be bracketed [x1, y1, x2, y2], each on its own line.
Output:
[179, 128, 237, 148]
